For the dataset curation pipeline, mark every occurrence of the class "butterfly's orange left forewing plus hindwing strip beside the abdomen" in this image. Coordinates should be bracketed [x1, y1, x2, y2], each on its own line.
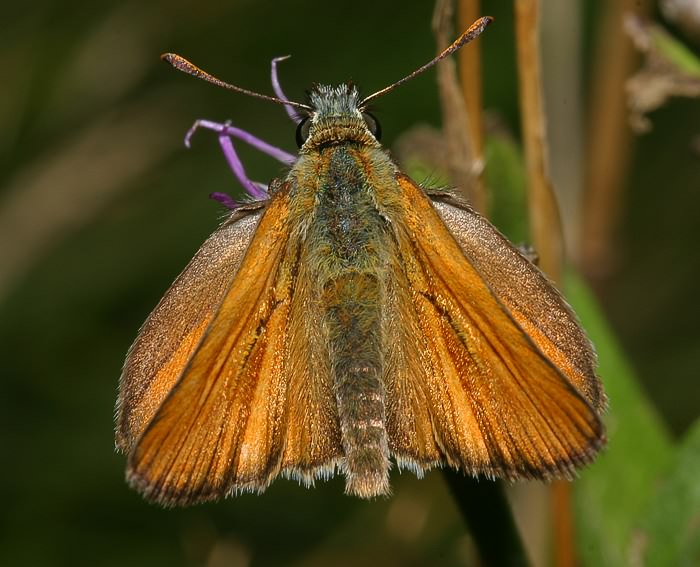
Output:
[121, 190, 341, 505]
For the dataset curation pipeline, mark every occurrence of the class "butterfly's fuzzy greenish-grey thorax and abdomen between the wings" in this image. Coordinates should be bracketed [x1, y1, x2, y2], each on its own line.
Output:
[308, 147, 390, 498]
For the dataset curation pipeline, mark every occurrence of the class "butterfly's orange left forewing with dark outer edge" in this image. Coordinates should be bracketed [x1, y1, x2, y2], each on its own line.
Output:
[123, 192, 298, 504]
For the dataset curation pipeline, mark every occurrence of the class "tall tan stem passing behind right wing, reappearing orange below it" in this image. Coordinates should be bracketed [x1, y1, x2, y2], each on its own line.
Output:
[515, 0, 575, 567]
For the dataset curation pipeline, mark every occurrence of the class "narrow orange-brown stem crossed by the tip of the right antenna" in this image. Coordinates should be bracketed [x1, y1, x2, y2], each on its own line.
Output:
[457, 0, 484, 169]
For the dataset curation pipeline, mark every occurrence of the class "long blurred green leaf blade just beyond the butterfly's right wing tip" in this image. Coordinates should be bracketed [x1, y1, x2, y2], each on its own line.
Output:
[565, 274, 673, 566]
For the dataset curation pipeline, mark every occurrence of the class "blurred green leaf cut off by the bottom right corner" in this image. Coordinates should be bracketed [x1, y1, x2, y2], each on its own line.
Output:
[640, 420, 700, 567]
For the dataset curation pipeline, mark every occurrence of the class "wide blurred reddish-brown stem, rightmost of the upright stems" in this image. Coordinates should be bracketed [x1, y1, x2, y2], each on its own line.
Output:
[577, 0, 643, 284]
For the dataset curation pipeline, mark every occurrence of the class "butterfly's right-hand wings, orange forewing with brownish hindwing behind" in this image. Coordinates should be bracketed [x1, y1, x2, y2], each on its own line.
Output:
[385, 176, 604, 479]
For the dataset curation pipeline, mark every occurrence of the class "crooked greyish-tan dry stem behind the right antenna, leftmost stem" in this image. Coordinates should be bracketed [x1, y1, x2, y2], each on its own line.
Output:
[433, 0, 486, 212]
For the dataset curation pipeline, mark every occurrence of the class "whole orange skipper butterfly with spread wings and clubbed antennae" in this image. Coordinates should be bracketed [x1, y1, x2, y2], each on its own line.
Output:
[116, 18, 606, 505]
